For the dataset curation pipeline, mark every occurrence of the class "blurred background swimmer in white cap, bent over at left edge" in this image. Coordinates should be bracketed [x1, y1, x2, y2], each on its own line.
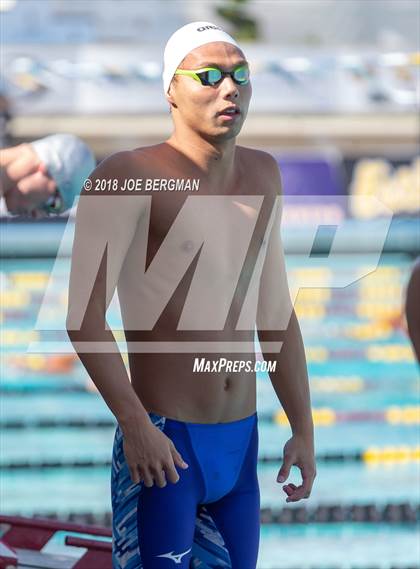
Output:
[0, 134, 96, 219]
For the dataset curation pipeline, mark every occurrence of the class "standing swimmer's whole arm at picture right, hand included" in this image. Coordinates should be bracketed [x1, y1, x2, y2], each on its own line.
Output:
[253, 157, 316, 502]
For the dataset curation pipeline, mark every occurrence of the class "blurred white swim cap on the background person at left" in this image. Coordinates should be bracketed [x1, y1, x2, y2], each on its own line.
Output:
[31, 134, 96, 210]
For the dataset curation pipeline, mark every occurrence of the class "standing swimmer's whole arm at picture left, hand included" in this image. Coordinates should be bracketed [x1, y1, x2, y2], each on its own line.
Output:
[66, 153, 189, 487]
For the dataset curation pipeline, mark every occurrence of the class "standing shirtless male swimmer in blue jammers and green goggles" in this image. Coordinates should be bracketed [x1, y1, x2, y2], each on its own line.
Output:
[67, 22, 316, 569]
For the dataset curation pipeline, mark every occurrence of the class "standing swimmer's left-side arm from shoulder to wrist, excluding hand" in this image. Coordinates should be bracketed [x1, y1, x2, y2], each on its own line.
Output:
[66, 153, 153, 428]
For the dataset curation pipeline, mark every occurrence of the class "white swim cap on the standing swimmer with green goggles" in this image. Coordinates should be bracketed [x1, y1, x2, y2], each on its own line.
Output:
[162, 22, 240, 95]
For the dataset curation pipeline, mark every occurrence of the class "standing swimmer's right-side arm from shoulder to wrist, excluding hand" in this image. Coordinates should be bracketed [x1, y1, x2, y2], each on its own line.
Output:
[256, 156, 313, 440]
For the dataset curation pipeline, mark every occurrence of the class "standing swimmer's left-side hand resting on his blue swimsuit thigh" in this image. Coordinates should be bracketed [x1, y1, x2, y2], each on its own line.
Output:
[123, 421, 188, 488]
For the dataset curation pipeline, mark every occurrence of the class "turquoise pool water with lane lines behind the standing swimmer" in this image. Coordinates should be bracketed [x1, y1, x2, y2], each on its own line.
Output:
[0, 255, 420, 569]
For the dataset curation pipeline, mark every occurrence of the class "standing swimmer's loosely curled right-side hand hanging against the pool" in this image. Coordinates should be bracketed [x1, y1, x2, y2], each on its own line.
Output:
[277, 434, 316, 502]
